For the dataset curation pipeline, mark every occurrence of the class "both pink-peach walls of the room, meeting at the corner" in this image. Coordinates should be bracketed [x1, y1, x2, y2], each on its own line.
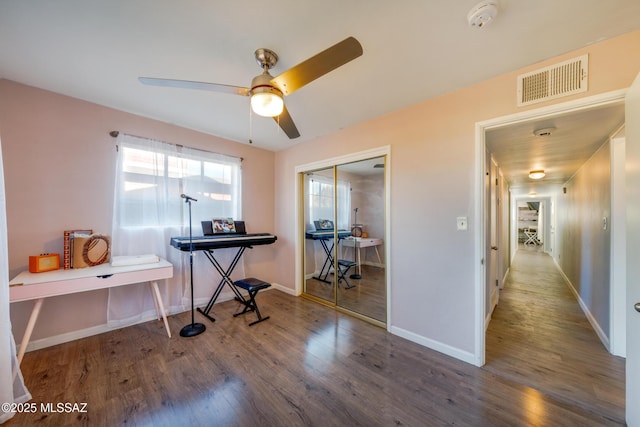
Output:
[0, 27, 640, 362]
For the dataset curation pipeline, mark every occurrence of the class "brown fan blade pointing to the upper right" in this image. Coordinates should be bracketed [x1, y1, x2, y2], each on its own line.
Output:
[271, 37, 362, 95]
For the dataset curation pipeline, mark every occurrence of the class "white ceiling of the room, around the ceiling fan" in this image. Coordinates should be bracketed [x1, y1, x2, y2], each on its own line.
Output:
[0, 0, 640, 195]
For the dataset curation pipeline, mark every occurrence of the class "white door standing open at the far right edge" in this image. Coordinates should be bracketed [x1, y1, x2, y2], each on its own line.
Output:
[625, 70, 640, 426]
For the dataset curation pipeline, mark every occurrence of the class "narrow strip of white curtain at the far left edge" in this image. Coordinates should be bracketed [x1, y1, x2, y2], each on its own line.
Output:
[0, 138, 31, 423]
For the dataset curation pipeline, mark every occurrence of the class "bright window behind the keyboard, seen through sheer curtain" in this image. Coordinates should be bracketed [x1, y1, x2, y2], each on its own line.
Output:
[115, 138, 241, 231]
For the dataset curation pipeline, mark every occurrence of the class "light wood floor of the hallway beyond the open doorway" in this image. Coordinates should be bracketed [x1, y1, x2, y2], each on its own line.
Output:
[484, 246, 625, 424]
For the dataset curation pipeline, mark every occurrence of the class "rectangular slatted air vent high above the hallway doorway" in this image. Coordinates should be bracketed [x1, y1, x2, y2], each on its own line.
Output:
[518, 55, 589, 107]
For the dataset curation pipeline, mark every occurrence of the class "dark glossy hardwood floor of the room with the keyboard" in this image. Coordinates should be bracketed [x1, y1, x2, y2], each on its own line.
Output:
[5, 252, 621, 426]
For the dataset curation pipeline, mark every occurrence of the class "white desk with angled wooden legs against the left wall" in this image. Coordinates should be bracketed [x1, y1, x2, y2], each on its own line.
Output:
[9, 259, 173, 363]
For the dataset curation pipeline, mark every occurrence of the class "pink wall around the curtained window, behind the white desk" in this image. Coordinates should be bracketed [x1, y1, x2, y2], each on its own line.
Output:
[0, 80, 278, 341]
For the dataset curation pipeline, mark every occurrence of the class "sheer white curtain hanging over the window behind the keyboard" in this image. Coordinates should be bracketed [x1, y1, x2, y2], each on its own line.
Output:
[108, 133, 244, 327]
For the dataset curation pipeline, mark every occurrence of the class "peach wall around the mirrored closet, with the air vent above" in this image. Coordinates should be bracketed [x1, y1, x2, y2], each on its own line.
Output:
[275, 31, 640, 357]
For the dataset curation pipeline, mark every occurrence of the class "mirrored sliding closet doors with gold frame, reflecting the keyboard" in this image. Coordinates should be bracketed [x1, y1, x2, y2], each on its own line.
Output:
[296, 148, 389, 327]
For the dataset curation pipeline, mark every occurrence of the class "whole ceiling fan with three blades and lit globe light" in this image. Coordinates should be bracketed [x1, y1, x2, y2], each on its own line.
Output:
[138, 37, 362, 139]
